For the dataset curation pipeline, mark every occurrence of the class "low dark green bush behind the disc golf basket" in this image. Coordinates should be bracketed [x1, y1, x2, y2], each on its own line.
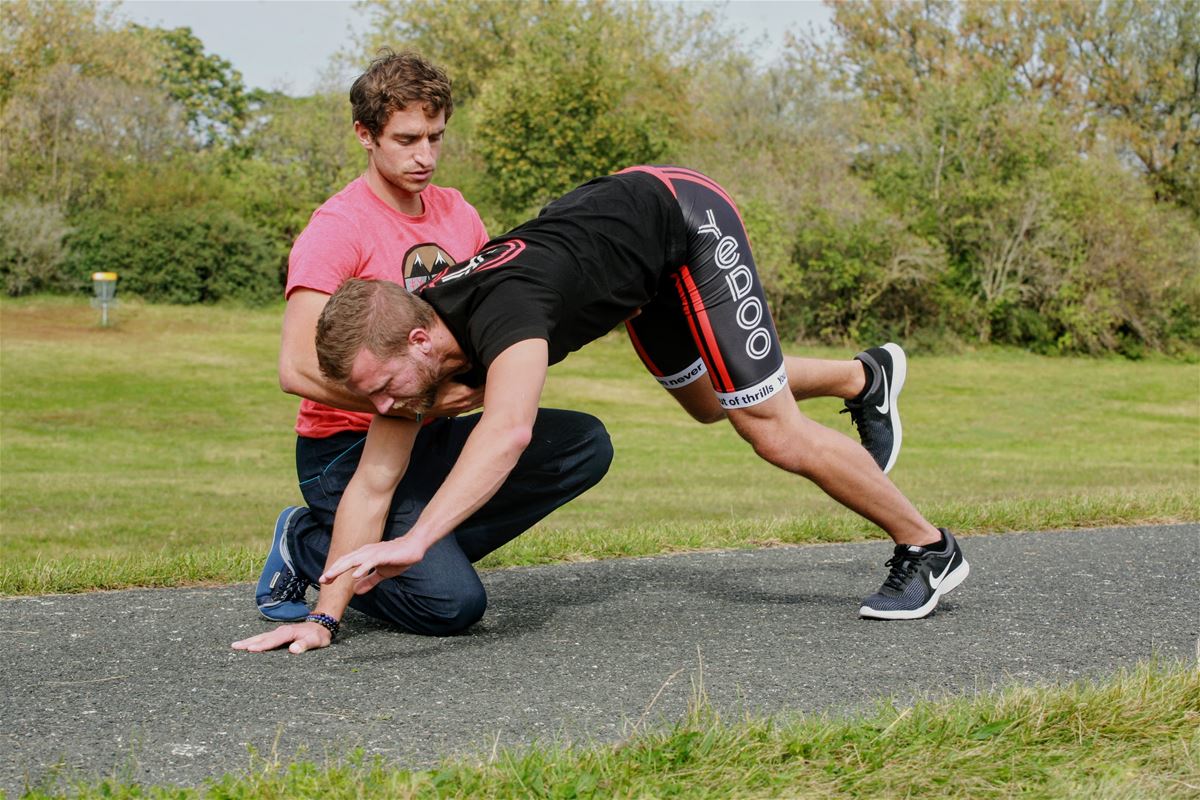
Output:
[67, 204, 281, 303]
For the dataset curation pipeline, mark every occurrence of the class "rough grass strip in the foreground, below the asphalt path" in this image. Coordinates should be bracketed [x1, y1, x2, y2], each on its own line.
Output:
[26, 663, 1200, 800]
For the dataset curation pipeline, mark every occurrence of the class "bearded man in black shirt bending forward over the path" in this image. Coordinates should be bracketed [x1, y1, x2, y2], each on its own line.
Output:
[307, 167, 968, 642]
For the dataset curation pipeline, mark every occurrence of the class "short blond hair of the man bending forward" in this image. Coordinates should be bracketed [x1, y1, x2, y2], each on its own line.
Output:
[317, 278, 433, 384]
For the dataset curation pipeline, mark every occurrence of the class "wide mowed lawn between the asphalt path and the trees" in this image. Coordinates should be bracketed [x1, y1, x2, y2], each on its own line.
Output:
[0, 297, 1200, 594]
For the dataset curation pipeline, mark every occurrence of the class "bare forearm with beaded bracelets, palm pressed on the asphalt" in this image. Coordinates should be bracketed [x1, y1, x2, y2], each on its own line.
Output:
[233, 416, 420, 652]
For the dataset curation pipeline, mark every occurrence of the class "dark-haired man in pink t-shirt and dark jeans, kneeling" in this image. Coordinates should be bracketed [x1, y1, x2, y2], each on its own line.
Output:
[239, 52, 612, 651]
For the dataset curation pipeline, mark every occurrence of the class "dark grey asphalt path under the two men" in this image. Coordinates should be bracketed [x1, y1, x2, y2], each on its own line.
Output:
[0, 524, 1200, 794]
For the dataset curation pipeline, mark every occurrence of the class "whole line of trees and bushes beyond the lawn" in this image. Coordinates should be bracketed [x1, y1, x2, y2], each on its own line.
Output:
[0, 0, 1200, 357]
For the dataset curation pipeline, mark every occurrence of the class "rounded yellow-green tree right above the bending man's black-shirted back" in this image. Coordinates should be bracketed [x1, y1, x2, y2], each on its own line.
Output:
[474, 2, 688, 221]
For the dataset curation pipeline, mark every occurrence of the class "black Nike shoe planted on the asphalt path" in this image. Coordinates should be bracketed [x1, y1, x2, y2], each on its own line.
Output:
[858, 528, 971, 619]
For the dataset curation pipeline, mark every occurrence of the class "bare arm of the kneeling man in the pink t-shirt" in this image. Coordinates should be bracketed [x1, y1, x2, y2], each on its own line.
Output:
[280, 289, 484, 416]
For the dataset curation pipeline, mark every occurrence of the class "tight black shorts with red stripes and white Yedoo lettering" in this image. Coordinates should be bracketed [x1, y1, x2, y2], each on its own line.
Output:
[623, 167, 787, 409]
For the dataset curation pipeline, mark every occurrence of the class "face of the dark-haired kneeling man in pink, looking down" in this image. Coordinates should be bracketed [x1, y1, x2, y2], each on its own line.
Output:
[354, 103, 446, 196]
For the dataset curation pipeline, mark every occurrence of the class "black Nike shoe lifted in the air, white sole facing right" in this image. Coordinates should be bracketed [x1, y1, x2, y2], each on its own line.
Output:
[841, 342, 908, 473]
